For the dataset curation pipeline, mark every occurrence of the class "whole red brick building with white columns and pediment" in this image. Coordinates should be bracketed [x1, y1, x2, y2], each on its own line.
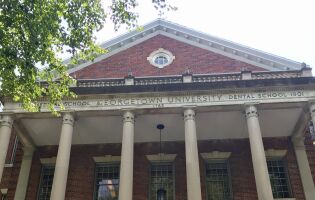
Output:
[0, 20, 315, 200]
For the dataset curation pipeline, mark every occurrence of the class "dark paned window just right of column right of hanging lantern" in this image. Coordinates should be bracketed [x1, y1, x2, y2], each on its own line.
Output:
[206, 160, 232, 200]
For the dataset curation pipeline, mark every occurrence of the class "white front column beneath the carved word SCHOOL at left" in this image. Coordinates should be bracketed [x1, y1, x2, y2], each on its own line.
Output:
[50, 113, 74, 200]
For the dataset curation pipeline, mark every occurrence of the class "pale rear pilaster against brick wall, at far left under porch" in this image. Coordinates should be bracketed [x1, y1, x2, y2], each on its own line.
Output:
[14, 147, 34, 200]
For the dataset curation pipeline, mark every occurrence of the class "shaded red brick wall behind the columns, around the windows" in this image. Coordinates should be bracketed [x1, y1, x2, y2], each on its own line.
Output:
[1, 134, 315, 200]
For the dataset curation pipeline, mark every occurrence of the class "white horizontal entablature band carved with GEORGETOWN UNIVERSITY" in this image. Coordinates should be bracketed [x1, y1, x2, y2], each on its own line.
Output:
[4, 88, 315, 113]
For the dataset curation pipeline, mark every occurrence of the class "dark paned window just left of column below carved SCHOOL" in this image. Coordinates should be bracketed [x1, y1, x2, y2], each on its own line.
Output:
[37, 165, 55, 200]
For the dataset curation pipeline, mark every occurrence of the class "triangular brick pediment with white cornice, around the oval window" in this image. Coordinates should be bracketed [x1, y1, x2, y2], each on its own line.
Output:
[66, 19, 301, 79]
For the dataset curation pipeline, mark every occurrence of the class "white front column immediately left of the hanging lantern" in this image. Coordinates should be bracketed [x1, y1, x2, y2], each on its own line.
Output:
[119, 111, 134, 200]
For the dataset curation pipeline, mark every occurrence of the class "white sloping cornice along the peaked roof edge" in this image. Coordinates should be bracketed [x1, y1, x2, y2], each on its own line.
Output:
[64, 19, 302, 73]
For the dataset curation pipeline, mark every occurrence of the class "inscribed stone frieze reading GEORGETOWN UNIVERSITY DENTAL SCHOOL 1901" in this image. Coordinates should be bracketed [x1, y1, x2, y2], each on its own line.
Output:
[5, 90, 315, 112]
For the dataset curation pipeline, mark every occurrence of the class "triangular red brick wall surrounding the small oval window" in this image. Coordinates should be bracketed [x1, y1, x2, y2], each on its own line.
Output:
[72, 35, 266, 79]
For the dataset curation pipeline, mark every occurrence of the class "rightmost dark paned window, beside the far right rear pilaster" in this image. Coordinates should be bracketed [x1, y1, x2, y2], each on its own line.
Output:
[267, 160, 291, 198]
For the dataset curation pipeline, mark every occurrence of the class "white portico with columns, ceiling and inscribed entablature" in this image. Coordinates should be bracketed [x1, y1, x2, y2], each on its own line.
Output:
[0, 69, 315, 200]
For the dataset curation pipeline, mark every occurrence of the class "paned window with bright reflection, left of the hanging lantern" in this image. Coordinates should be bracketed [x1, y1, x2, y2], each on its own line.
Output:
[94, 163, 119, 200]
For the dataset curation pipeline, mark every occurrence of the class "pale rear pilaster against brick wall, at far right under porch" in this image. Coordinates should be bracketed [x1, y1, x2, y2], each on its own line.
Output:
[292, 138, 315, 200]
